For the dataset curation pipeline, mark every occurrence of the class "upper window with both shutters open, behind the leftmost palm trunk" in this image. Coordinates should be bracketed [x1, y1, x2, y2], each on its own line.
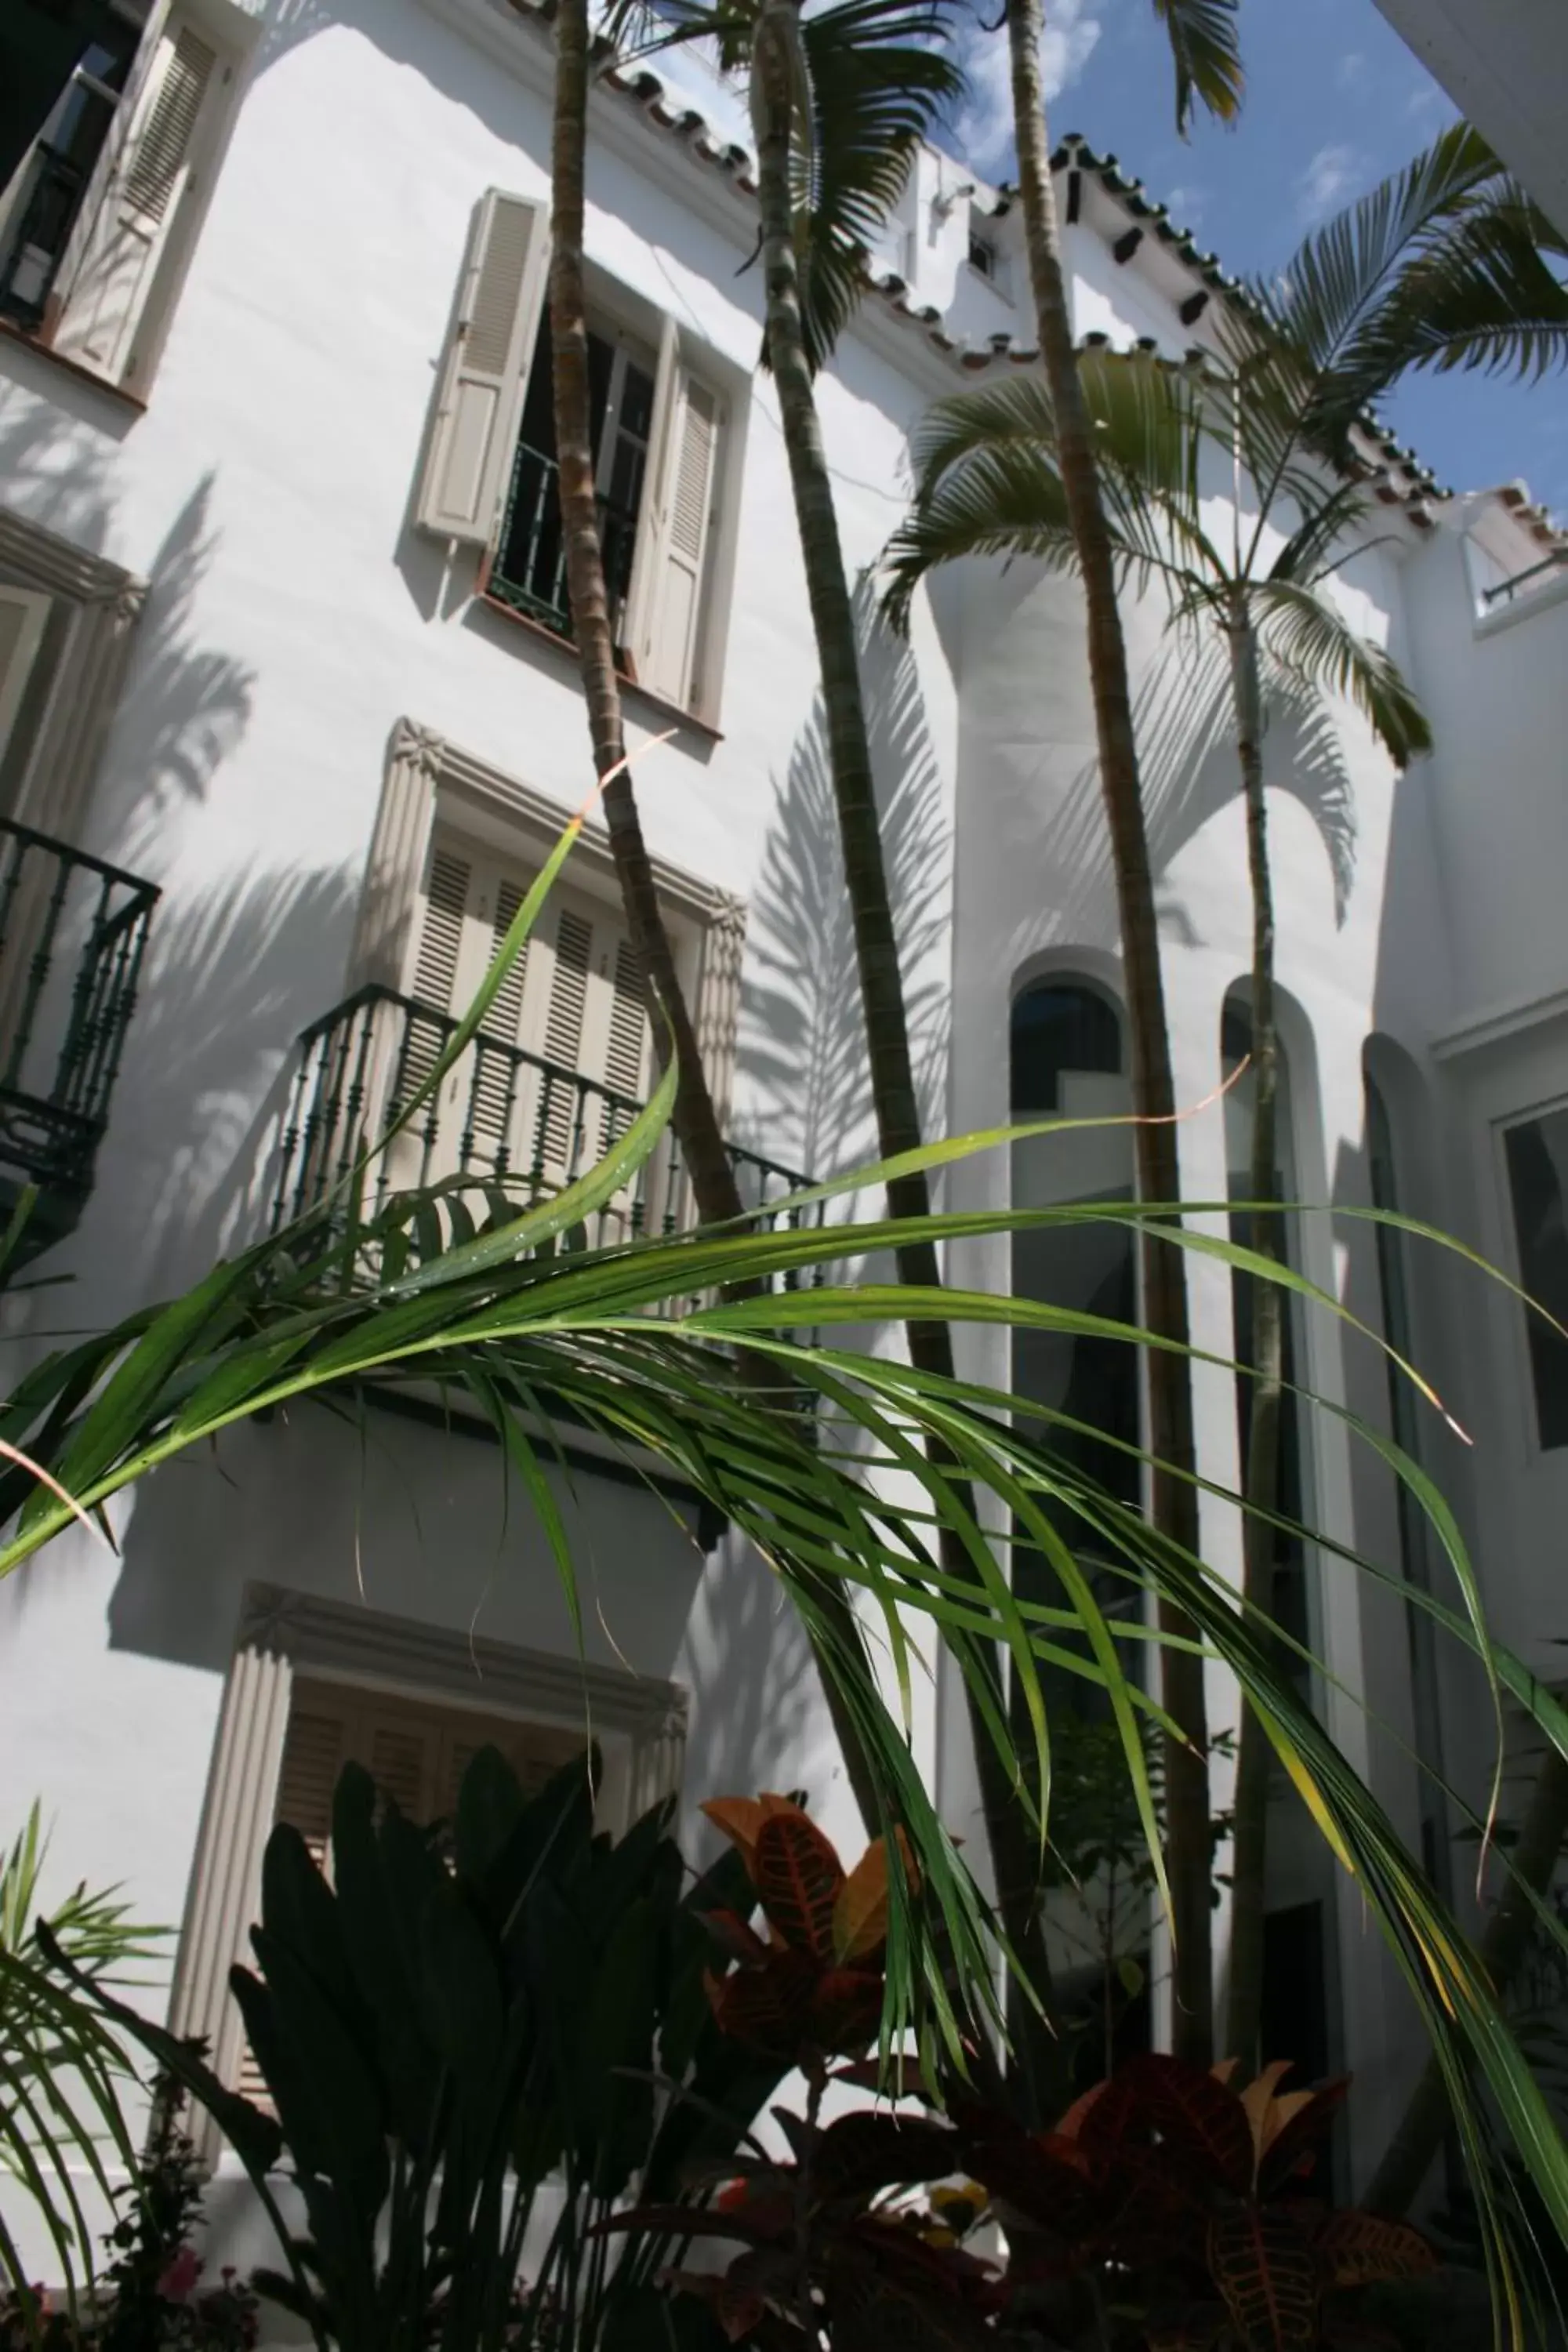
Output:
[419, 188, 736, 720]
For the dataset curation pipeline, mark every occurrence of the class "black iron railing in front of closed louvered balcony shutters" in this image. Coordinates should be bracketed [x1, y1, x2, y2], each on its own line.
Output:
[273, 988, 822, 1287]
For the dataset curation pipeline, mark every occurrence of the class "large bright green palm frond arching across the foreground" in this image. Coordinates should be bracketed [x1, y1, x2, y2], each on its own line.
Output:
[0, 927, 1568, 2305]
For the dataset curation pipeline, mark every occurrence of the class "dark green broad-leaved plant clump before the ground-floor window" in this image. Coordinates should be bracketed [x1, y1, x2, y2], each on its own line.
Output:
[41, 1750, 785, 2352]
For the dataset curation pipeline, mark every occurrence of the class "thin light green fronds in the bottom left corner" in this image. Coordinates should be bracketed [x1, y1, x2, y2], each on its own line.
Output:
[0, 1802, 167, 2324]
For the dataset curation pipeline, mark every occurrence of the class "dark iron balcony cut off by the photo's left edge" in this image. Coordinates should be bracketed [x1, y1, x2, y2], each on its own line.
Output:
[0, 818, 158, 1254]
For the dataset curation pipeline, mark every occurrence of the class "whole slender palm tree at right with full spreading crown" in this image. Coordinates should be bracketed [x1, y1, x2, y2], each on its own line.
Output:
[888, 127, 1568, 2065]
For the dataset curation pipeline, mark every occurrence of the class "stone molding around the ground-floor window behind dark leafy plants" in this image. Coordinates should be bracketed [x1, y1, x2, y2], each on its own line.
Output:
[169, 1583, 687, 2169]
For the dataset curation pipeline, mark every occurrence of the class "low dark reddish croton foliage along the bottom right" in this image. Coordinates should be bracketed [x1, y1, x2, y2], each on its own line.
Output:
[597, 1957, 1434, 2352]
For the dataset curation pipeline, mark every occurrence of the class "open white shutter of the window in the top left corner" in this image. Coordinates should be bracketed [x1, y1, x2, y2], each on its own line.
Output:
[54, 19, 230, 381]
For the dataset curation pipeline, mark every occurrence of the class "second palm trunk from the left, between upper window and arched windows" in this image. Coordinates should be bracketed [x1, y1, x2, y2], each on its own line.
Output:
[753, 0, 1067, 2114]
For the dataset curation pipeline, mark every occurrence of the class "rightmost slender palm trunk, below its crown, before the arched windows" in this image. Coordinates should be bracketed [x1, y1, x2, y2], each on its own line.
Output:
[1225, 600, 1288, 2074]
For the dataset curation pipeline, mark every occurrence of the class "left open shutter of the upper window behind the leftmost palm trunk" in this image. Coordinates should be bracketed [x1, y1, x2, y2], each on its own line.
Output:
[416, 188, 550, 546]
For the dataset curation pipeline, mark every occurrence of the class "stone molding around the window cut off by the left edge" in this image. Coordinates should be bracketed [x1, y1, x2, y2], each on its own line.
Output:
[0, 508, 146, 842]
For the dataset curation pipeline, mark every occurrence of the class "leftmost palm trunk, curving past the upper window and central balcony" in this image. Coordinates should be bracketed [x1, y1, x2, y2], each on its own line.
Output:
[550, 0, 881, 1835]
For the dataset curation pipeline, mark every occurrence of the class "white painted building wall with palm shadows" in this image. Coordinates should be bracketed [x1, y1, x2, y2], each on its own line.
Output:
[0, 0, 1568, 2249]
